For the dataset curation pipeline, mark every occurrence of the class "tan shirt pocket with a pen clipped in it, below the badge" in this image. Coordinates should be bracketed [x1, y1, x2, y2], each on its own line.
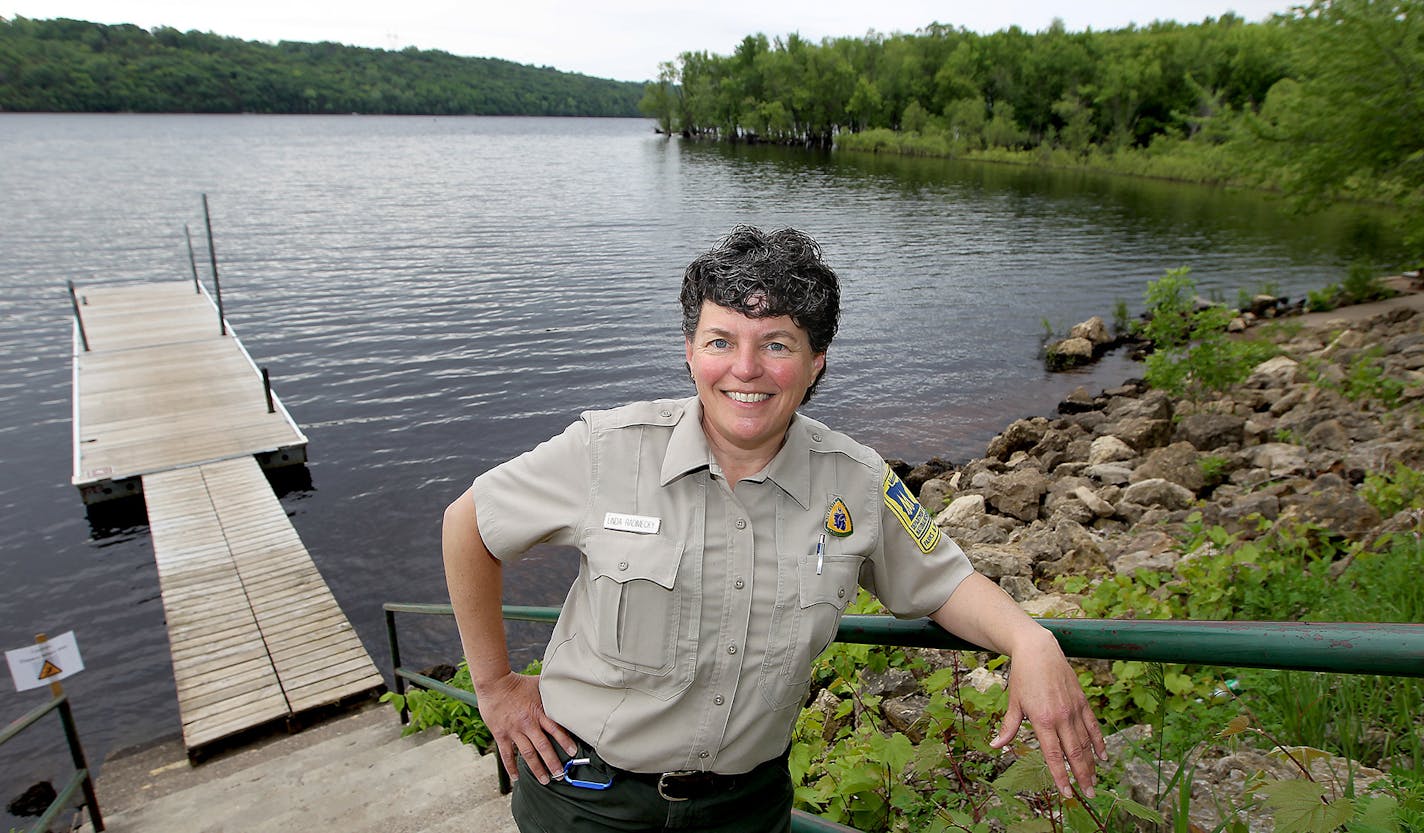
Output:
[760, 555, 864, 709]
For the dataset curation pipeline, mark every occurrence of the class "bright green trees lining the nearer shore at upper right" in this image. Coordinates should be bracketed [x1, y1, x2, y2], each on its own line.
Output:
[641, 0, 1424, 255]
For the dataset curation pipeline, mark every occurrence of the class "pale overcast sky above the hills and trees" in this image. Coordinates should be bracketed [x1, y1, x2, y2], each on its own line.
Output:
[8, 0, 1293, 81]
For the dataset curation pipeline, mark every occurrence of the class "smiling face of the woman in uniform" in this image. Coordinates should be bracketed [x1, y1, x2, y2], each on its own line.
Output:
[686, 300, 826, 469]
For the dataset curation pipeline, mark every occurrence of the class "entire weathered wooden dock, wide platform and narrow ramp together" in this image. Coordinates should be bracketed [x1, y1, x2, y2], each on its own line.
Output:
[74, 282, 384, 759]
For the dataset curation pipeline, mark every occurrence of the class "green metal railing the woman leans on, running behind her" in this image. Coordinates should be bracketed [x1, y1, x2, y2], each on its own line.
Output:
[383, 602, 1424, 833]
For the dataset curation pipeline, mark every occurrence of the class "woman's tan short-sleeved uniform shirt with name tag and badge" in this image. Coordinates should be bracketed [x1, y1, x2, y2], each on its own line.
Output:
[474, 399, 973, 773]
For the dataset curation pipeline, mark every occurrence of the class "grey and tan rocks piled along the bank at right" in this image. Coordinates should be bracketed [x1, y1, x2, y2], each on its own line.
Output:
[873, 270, 1424, 830]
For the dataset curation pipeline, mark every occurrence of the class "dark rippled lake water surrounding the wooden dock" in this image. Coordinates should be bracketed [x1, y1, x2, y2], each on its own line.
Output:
[0, 114, 1397, 814]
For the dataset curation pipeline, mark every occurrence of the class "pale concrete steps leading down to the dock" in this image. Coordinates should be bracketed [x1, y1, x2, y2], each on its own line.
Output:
[77, 713, 514, 833]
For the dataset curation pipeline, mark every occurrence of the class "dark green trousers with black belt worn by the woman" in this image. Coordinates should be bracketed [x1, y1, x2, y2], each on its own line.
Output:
[511, 743, 792, 833]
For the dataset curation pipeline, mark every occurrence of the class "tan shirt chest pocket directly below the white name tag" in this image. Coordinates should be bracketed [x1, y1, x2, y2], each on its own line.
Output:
[585, 530, 696, 696]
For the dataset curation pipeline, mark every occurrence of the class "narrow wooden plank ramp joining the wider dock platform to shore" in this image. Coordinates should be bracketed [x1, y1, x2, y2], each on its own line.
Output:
[144, 457, 383, 750]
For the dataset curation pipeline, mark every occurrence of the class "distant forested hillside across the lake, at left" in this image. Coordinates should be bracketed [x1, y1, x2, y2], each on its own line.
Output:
[0, 17, 644, 115]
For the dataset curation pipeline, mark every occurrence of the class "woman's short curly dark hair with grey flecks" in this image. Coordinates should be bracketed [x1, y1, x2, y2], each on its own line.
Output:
[681, 225, 840, 402]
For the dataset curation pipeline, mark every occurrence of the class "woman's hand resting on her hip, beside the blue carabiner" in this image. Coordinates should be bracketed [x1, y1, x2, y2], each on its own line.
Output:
[474, 672, 578, 783]
